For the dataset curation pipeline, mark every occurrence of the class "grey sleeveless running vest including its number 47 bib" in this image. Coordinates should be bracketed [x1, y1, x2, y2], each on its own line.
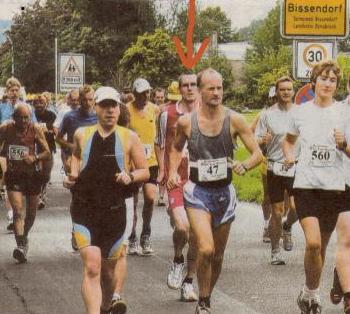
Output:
[188, 109, 235, 187]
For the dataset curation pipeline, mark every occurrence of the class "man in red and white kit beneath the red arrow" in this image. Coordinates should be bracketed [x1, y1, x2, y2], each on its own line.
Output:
[156, 74, 199, 301]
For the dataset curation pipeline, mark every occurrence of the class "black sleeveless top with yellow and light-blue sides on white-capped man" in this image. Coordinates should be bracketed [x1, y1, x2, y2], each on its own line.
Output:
[74, 126, 131, 208]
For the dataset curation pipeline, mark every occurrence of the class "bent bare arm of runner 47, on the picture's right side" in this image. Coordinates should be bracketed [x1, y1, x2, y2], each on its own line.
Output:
[231, 113, 263, 174]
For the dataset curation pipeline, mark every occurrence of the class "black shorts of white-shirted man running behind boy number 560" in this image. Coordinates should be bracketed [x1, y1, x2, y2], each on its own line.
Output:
[267, 170, 294, 204]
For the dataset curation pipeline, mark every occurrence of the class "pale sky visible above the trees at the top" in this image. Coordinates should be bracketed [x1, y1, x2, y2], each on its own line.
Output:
[0, 0, 276, 29]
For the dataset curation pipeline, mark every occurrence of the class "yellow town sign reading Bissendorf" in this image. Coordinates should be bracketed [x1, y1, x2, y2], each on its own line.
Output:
[280, 0, 349, 38]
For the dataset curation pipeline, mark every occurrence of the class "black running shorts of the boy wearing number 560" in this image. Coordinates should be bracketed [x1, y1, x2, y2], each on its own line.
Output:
[294, 189, 343, 232]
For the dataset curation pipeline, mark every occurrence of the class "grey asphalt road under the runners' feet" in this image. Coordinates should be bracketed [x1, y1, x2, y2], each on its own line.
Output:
[0, 155, 342, 314]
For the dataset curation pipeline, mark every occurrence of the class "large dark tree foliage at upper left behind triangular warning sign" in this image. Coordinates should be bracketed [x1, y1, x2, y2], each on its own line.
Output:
[0, 0, 156, 91]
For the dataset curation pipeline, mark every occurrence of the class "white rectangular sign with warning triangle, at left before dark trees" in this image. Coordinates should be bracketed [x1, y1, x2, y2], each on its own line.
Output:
[58, 53, 85, 93]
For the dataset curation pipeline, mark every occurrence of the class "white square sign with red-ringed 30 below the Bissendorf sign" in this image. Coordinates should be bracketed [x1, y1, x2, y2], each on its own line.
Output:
[293, 40, 336, 81]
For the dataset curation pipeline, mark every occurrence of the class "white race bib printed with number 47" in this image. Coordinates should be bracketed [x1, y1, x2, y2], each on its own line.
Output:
[197, 157, 227, 182]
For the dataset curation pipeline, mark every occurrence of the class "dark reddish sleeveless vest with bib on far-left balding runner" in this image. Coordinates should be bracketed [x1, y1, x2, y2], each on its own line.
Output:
[1, 123, 38, 173]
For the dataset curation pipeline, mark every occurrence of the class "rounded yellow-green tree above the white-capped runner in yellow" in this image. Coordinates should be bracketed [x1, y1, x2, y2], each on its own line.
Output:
[120, 29, 184, 87]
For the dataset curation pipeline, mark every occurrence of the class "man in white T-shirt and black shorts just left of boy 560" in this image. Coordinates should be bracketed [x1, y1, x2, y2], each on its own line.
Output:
[255, 76, 298, 265]
